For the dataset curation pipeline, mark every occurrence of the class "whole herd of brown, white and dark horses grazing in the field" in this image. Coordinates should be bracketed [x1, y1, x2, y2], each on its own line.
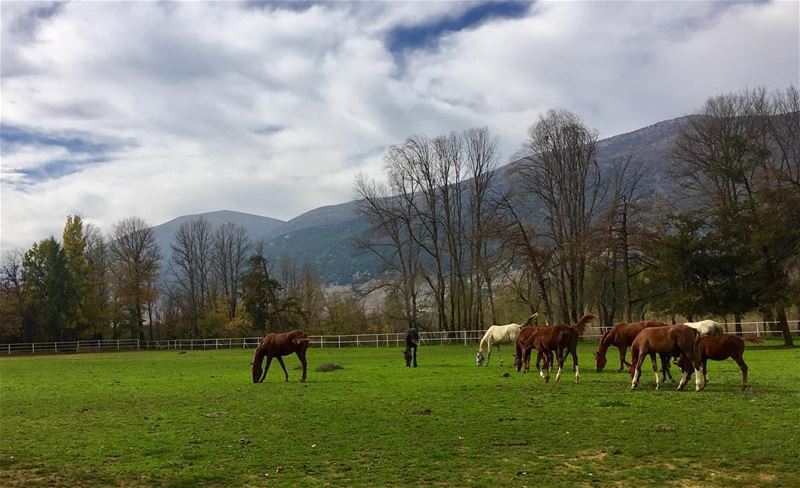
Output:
[250, 314, 763, 391]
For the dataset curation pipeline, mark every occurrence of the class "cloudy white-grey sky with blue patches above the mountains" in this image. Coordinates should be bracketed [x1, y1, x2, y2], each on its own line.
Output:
[0, 1, 800, 250]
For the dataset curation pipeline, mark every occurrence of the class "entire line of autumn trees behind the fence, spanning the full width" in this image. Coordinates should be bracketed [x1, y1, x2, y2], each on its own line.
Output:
[0, 87, 800, 344]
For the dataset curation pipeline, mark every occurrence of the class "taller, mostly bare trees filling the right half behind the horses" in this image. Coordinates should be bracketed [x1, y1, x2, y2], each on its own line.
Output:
[356, 87, 800, 344]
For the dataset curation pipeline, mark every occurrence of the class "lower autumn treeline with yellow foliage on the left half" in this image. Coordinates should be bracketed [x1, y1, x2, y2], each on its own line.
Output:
[0, 216, 370, 341]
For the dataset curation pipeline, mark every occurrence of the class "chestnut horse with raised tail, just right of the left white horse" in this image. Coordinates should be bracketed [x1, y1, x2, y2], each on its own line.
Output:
[523, 314, 595, 383]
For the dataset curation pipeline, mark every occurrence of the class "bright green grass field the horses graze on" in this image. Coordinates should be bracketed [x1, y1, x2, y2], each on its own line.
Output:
[0, 342, 800, 486]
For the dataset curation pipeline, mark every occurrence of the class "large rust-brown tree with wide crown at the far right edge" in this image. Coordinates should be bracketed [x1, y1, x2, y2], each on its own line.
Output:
[672, 89, 800, 345]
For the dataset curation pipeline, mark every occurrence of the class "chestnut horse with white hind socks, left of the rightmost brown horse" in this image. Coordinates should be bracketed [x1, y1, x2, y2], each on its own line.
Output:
[630, 324, 703, 391]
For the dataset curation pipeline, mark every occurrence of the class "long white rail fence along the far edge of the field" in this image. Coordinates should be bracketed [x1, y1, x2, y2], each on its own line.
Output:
[0, 320, 800, 355]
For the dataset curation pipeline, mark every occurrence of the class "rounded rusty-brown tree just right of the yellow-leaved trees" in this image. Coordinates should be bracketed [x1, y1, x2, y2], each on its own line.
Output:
[109, 217, 161, 340]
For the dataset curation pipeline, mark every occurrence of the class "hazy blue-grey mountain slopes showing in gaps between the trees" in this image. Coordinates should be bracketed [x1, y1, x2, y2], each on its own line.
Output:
[154, 117, 685, 285]
